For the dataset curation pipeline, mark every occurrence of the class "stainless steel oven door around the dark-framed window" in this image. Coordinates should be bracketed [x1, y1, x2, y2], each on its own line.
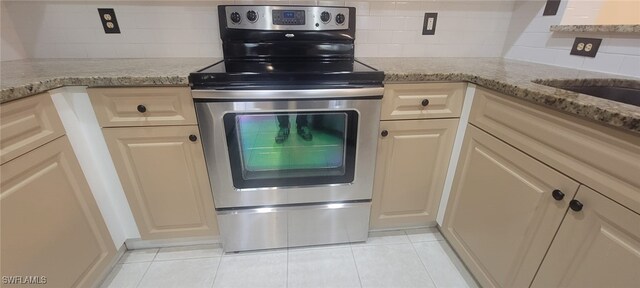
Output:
[196, 89, 380, 208]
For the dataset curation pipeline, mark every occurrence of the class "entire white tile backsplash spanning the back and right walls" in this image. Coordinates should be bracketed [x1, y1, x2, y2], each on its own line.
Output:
[0, 0, 640, 76]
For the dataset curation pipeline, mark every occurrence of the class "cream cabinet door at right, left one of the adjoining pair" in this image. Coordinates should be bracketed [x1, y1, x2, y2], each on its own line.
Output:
[442, 125, 578, 287]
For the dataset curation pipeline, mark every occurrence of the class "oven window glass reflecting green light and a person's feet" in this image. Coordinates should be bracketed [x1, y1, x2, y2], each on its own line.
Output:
[224, 111, 358, 188]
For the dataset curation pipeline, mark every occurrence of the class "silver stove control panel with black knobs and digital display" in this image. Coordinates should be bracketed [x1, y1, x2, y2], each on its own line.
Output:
[224, 5, 355, 31]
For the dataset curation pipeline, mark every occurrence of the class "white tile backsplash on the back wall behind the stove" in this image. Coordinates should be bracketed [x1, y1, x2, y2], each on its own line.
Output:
[1, 0, 513, 60]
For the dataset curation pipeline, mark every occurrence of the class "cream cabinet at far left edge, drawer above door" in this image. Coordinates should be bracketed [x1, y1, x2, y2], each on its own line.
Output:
[0, 93, 116, 287]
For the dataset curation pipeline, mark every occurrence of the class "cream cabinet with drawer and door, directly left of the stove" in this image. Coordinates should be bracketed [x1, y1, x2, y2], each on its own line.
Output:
[87, 87, 218, 240]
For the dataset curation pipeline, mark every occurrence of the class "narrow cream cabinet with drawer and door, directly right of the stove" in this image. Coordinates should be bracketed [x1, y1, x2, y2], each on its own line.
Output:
[370, 83, 465, 229]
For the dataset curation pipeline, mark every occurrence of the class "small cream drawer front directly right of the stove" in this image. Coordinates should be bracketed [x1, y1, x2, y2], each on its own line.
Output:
[380, 83, 467, 120]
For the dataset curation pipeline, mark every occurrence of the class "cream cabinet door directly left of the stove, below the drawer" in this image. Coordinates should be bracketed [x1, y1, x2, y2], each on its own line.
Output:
[102, 125, 218, 239]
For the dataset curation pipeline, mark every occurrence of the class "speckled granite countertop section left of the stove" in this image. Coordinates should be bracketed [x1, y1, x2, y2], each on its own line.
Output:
[0, 58, 221, 103]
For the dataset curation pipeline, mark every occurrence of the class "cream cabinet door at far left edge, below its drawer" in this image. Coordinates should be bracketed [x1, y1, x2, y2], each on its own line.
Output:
[0, 136, 116, 287]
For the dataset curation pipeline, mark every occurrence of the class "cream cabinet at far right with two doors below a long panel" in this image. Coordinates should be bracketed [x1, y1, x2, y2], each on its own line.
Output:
[442, 88, 640, 287]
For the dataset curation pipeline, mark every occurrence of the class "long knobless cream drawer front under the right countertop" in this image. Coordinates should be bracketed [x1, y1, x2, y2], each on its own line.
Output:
[469, 89, 640, 212]
